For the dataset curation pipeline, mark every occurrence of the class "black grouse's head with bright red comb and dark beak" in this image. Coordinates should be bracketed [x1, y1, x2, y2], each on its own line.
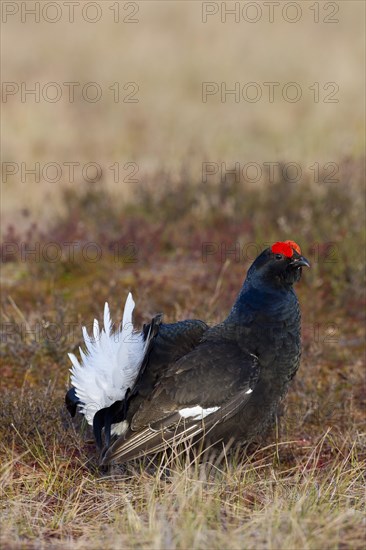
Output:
[247, 241, 310, 294]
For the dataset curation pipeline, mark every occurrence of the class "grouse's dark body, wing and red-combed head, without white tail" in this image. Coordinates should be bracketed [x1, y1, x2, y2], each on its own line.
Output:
[65, 242, 309, 464]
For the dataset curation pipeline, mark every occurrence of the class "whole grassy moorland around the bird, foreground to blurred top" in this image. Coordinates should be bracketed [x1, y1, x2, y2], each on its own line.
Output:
[0, 0, 366, 550]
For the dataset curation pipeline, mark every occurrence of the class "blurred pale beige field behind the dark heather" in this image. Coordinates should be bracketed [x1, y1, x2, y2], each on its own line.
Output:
[2, 0, 365, 227]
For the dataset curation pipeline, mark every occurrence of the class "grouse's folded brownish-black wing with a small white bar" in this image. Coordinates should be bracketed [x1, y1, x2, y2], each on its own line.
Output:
[102, 340, 259, 464]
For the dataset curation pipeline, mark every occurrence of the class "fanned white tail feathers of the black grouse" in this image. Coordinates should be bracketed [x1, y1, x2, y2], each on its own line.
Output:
[69, 293, 145, 425]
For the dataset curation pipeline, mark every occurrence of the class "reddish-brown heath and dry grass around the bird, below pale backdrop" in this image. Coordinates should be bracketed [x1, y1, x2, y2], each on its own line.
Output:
[0, 161, 366, 550]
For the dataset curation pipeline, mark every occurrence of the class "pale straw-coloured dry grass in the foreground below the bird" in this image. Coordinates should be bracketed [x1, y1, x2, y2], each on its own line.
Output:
[1, 384, 366, 550]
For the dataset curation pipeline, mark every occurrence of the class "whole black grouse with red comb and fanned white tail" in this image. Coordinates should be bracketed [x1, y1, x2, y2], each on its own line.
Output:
[65, 241, 310, 464]
